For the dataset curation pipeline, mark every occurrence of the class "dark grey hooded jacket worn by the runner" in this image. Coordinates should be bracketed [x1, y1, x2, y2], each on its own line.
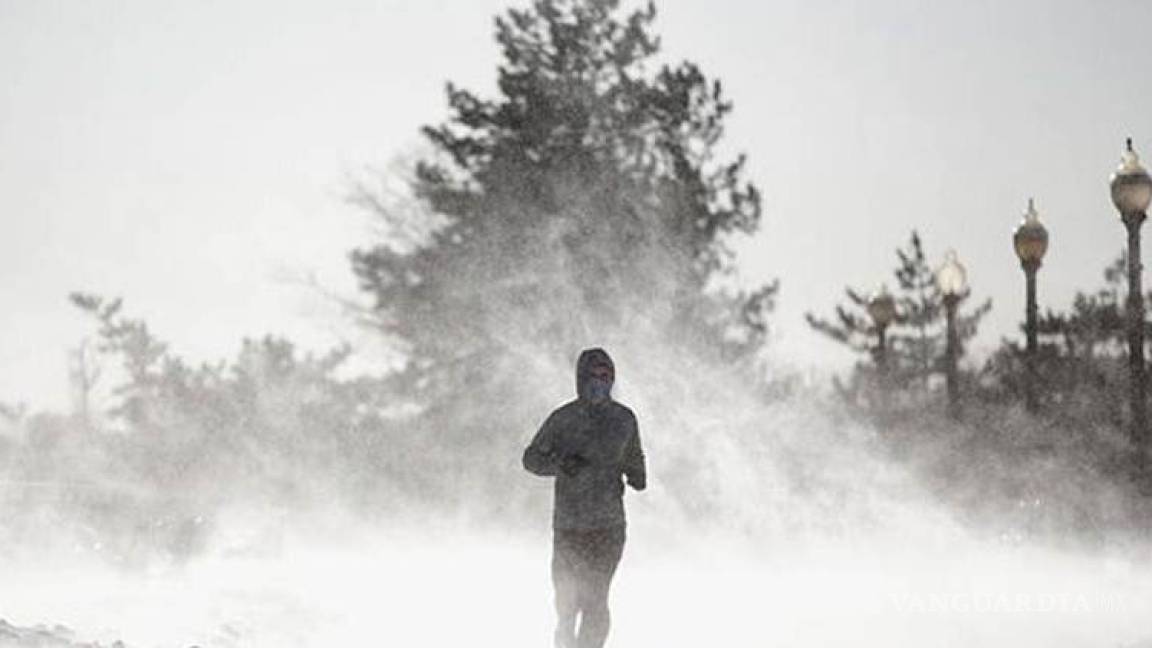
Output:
[523, 348, 647, 529]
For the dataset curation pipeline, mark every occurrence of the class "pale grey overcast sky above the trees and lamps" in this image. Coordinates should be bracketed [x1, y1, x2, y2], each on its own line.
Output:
[0, 0, 1152, 407]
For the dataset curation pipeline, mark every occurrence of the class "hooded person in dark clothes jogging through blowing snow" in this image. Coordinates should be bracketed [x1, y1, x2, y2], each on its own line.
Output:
[524, 348, 646, 648]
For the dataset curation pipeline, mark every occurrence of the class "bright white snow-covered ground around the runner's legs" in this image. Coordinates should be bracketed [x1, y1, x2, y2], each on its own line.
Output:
[0, 523, 1152, 648]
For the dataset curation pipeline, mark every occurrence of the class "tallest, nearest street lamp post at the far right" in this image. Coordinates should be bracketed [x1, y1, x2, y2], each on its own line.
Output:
[1109, 138, 1152, 476]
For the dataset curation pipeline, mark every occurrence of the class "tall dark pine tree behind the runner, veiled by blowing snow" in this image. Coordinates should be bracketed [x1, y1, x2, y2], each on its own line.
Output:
[353, 0, 775, 511]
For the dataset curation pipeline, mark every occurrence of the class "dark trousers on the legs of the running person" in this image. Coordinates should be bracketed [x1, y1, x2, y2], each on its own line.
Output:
[552, 525, 624, 648]
